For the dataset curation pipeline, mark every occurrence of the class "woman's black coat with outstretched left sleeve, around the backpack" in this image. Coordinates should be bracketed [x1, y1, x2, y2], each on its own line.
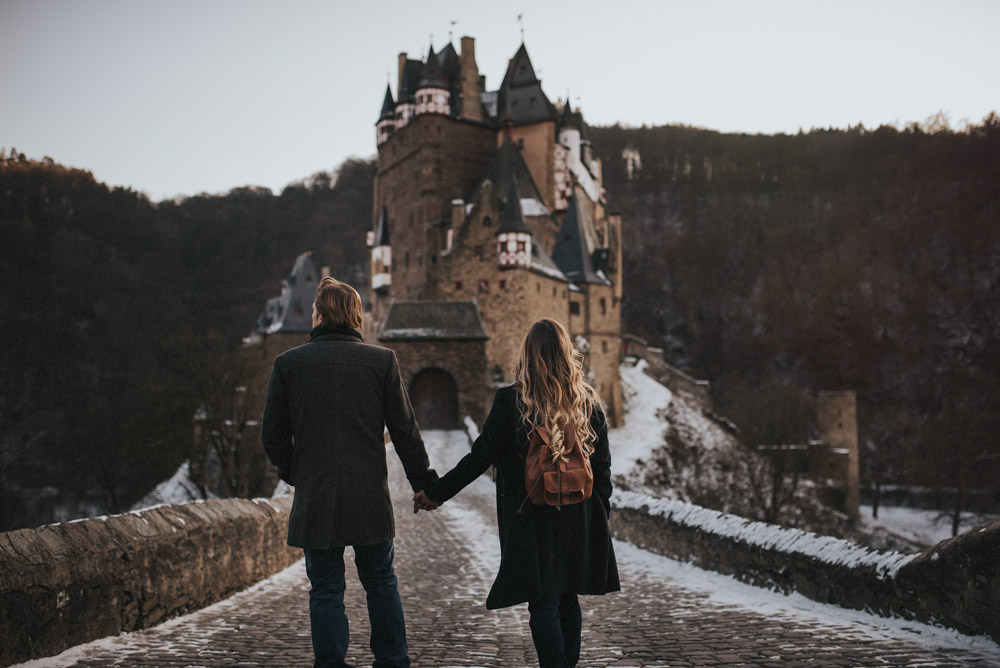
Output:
[424, 387, 621, 610]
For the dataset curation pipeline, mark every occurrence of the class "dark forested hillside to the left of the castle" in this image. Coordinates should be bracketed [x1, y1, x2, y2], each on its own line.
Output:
[0, 153, 372, 530]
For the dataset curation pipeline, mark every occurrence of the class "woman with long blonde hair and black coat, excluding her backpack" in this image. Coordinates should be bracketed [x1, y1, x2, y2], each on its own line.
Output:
[414, 319, 620, 668]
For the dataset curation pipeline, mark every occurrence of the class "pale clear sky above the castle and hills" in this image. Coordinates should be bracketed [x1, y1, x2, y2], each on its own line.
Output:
[0, 0, 1000, 200]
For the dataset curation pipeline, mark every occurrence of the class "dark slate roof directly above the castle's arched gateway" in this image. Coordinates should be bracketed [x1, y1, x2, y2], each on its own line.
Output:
[378, 301, 489, 341]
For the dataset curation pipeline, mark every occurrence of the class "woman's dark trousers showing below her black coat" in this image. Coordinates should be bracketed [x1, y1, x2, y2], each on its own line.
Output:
[528, 594, 583, 668]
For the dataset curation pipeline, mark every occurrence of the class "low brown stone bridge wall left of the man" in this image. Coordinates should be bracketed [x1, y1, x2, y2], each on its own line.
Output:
[0, 497, 302, 666]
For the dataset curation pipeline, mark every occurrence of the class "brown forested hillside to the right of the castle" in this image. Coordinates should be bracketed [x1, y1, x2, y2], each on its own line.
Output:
[591, 114, 1000, 516]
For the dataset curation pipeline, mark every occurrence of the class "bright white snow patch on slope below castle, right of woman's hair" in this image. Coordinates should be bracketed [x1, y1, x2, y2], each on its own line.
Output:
[608, 360, 673, 476]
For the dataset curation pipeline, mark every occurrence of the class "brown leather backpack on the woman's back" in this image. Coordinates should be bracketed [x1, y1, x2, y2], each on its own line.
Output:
[517, 424, 594, 513]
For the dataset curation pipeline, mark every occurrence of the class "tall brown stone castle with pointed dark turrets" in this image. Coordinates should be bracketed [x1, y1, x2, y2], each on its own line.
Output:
[366, 37, 623, 428]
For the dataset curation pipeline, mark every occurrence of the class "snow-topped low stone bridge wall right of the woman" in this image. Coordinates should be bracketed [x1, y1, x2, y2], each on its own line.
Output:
[612, 492, 1000, 642]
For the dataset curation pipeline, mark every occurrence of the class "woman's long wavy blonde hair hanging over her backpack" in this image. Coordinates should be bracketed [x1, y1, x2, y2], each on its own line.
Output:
[514, 318, 600, 461]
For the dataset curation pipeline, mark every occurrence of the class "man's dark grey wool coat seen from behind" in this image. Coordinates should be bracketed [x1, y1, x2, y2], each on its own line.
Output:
[261, 327, 437, 549]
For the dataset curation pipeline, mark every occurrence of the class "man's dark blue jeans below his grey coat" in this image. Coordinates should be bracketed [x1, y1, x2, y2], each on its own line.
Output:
[305, 540, 410, 668]
